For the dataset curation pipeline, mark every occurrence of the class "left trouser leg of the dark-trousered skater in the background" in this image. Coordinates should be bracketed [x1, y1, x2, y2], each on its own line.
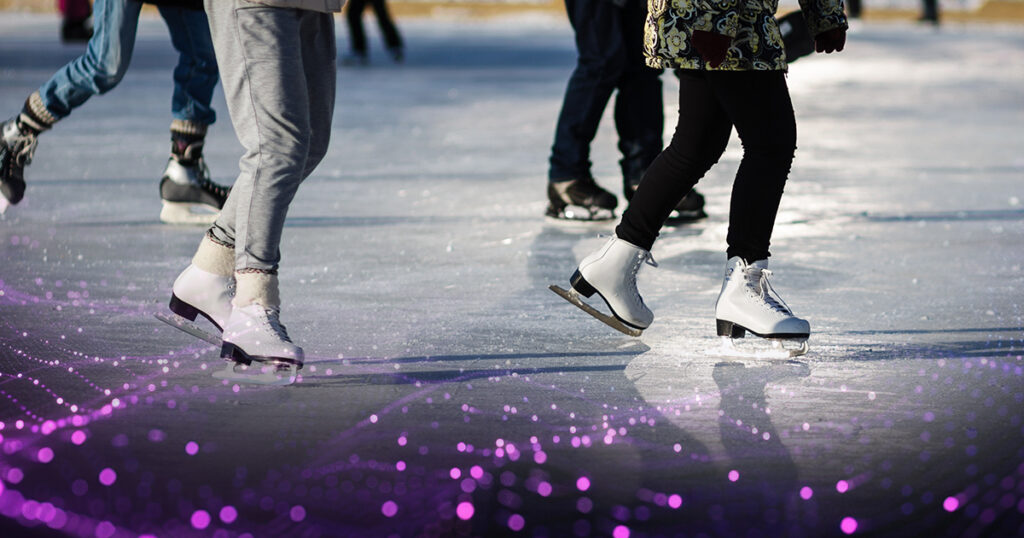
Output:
[548, 0, 627, 181]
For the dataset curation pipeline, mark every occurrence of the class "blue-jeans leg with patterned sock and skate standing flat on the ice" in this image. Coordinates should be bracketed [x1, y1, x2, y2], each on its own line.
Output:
[159, 6, 228, 223]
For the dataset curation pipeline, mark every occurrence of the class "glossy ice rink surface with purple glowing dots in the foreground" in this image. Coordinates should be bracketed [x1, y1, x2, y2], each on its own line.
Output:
[0, 14, 1024, 538]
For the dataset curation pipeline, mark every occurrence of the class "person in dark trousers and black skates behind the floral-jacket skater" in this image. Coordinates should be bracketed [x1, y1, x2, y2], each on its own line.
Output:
[547, 0, 707, 220]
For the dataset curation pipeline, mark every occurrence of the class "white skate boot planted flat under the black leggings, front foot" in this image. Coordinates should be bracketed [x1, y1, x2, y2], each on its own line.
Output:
[715, 256, 811, 338]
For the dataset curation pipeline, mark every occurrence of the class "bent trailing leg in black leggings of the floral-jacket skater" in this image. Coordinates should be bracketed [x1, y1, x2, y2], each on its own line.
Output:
[615, 71, 732, 250]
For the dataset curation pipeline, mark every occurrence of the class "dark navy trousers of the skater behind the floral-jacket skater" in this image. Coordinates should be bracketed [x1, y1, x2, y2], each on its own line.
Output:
[548, 0, 665, 183]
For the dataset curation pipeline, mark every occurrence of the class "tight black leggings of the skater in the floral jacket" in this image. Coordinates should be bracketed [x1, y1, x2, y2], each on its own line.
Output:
[615, 71, 797, 261]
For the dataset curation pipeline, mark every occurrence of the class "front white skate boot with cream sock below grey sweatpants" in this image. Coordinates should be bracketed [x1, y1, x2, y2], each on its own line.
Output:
[220, 273, 304, 367]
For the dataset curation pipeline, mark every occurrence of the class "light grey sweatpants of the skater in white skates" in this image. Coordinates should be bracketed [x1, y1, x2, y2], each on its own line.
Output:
[205, 0, 337, 272]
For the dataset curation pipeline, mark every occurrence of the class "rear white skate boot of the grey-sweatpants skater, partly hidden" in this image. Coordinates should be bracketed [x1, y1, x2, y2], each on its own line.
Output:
[170, 237, 234, 330]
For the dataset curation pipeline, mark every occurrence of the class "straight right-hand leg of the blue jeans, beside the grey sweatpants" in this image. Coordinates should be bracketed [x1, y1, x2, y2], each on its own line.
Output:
[159, 6, 217, 125]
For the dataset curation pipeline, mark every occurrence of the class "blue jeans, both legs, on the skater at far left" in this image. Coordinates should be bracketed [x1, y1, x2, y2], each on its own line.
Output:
[39, 0, 217, 125]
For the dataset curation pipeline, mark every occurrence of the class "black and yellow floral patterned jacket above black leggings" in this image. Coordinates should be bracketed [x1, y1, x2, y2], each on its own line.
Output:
[644, 0, 848, 71]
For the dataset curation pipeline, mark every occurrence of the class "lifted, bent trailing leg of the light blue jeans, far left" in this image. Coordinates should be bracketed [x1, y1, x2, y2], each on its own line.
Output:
[39, 0, 142, 119]
